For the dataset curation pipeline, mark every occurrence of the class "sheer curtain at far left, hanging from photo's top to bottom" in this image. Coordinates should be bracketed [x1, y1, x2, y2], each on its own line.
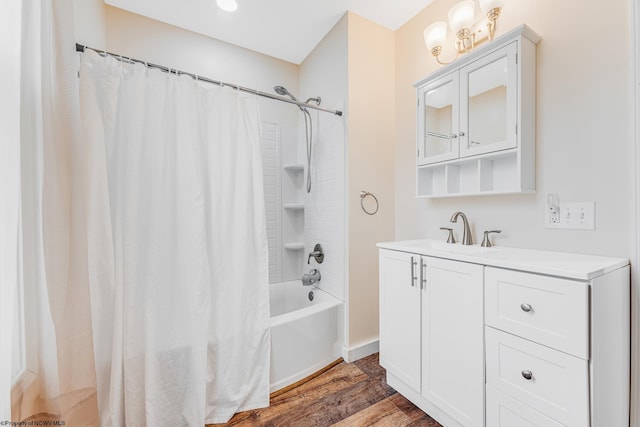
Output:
[10, 0, 98, 426]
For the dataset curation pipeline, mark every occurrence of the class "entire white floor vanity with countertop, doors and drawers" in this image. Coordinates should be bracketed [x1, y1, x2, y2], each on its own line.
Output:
[378, 240, 630, 427]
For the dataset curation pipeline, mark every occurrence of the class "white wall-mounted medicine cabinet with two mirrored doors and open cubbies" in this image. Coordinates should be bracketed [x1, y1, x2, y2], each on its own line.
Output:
[414, 26, 539, 197]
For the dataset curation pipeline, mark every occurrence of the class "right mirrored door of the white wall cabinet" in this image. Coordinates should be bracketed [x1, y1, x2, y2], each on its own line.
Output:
[460, 43, 517, 155]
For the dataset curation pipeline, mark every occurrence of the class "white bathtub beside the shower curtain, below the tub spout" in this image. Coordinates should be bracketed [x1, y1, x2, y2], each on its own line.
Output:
[269, 280, 342, 392]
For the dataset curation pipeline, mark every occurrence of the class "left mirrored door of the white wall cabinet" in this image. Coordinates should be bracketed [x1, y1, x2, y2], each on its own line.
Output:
[418, 73, 459, 164]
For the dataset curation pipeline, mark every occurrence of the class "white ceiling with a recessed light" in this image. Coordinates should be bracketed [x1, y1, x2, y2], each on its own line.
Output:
[104, 0, 432, 64]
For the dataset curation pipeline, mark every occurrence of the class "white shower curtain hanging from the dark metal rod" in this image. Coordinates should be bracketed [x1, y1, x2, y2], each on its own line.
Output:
[80, 50, 270, 426]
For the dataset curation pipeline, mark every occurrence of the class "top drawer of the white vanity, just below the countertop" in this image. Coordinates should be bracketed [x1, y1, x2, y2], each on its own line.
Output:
[485, 267, 589, 359]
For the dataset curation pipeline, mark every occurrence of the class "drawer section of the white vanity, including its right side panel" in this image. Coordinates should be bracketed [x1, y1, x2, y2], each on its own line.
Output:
[485, 267, 630, 427]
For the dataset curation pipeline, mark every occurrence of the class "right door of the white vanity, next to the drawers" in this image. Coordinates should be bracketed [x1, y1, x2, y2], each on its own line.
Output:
[422, 257, 484, 427]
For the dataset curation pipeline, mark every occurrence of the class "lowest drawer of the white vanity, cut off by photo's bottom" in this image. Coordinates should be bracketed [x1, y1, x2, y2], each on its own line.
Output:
[486, 386, 563, 427]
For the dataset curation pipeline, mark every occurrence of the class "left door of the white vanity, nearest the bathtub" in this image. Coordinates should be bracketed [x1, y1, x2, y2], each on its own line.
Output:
[380, 250, 420, 392]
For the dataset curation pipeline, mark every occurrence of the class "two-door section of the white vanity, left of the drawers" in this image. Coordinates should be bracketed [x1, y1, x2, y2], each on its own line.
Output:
[380, 250, 484, 427]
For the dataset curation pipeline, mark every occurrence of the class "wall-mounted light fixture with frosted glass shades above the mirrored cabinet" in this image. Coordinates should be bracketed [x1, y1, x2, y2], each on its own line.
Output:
[424, 0, 504, 65]
